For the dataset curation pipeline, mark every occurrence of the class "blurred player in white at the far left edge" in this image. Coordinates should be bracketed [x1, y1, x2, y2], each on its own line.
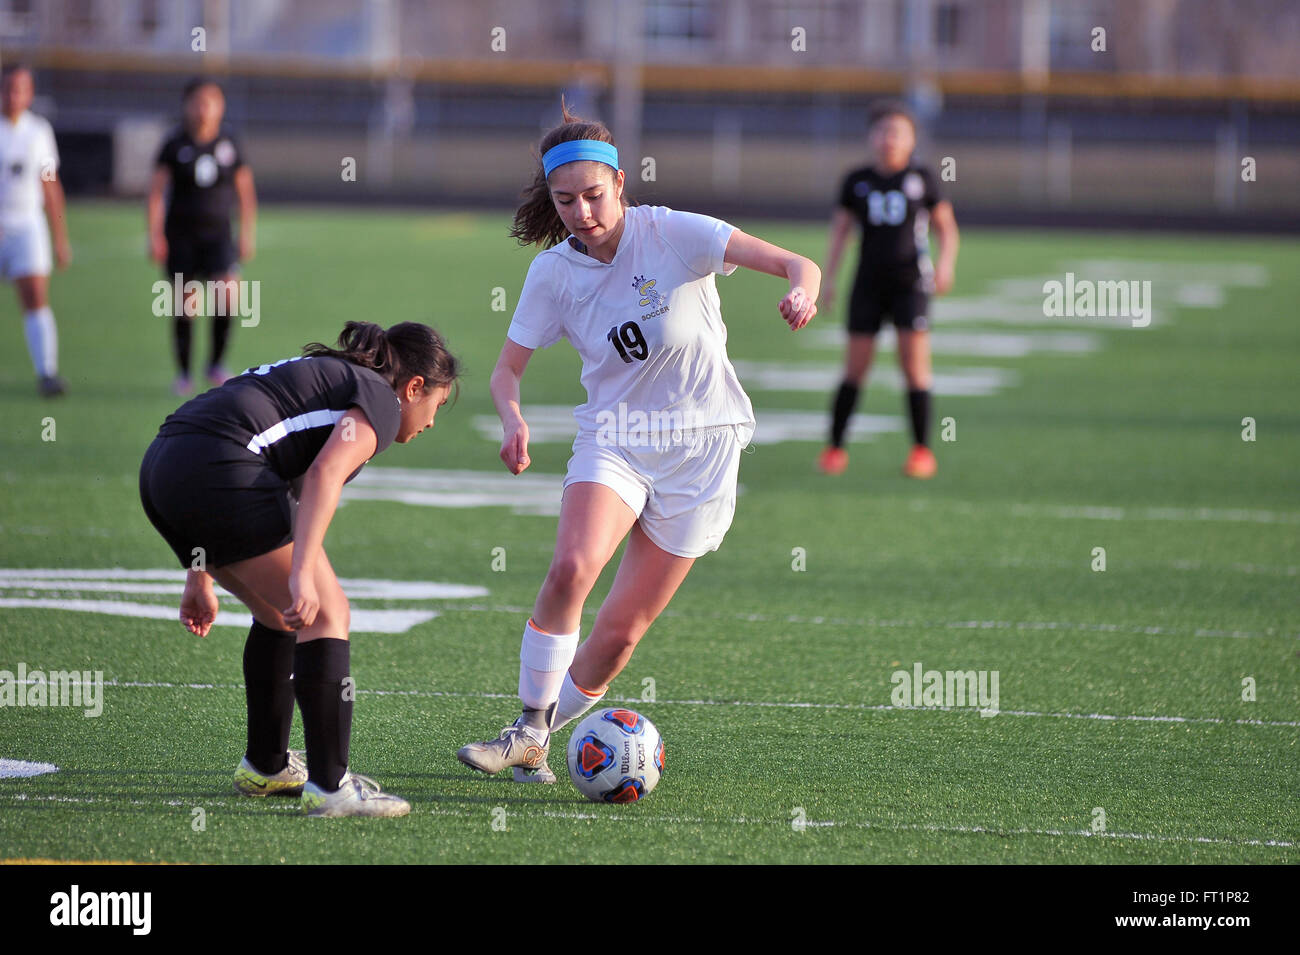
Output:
[0, 65, 73, 396]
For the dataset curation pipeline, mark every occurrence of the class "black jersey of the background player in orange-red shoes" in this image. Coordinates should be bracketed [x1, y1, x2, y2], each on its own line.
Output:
[840, 165, 944, 274]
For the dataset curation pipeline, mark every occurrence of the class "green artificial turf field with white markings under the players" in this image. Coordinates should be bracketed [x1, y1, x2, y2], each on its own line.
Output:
[0, 204, 1300, 863]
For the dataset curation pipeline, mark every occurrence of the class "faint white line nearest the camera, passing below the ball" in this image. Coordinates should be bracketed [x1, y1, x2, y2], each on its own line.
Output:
[0, 790, 1296, 848]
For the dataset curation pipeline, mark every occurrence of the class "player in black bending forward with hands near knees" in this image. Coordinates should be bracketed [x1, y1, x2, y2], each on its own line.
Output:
[140, 322, 460, 816]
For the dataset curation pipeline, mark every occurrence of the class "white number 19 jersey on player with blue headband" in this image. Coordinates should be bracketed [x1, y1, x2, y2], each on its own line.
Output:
[507, 205, 754, 435]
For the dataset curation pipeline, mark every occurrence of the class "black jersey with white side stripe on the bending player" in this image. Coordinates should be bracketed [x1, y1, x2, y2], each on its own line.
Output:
[159, 356, 402, 481]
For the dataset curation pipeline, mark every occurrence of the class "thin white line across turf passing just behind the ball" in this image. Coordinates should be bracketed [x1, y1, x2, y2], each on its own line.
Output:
[5, 680, 1300, 726]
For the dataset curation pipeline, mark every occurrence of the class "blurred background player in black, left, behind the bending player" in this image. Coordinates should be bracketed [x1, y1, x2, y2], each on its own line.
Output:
[148, 78, 257, 395]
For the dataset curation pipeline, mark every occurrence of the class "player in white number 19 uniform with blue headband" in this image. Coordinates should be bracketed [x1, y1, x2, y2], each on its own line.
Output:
[456, 102, 822, 782]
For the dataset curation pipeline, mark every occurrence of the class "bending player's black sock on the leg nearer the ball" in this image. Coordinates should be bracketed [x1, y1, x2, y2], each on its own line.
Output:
[294, 638, 352, 793]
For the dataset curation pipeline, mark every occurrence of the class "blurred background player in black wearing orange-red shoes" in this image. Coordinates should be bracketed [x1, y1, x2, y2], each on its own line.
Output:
[820, 103, 958, 478]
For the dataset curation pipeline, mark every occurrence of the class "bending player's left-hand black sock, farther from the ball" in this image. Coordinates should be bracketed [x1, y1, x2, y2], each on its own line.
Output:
[244, 620, 298, 776]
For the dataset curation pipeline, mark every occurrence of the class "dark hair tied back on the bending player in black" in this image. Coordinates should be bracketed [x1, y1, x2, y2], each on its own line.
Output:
[303, 322, 462, 394]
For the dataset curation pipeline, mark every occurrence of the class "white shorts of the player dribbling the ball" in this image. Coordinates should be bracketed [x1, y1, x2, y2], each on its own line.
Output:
[564, 425, 754, 557]
